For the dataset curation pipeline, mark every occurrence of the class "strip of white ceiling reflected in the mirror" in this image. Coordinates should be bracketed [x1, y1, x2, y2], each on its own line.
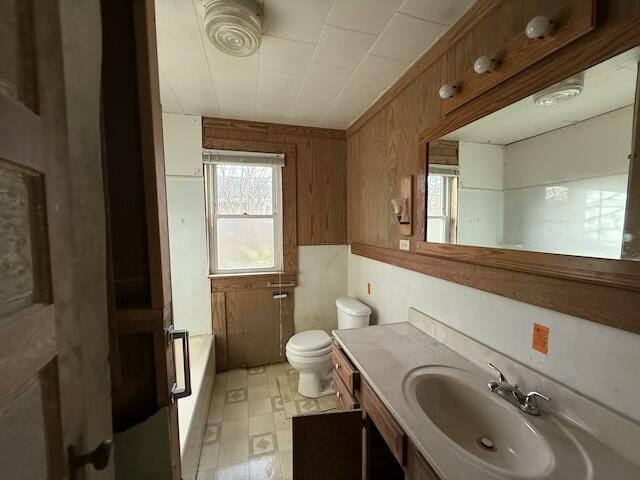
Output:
[443, 47, 640, 145]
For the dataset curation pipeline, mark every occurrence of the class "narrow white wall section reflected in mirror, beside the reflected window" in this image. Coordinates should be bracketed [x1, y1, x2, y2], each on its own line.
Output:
[458, 142, 504, 247]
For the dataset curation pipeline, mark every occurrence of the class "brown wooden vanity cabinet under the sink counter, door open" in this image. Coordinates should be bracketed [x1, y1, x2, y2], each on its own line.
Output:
[292, 344, 438, 480]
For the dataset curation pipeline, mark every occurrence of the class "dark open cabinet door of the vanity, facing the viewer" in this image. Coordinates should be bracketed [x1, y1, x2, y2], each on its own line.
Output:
[292, 410, 363, 480]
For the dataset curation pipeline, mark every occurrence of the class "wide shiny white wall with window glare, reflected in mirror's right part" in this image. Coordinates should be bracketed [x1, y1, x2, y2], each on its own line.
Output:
[503, 106, 633, 258]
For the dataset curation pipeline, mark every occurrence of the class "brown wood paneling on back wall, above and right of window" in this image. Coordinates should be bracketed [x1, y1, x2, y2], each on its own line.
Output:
[202, 118, 347, 245]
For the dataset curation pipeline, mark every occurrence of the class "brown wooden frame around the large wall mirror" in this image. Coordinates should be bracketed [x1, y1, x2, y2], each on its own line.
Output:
[416, 33, 640, 333]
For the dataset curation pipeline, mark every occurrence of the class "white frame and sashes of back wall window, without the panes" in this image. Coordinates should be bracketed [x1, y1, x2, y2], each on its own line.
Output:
[204, 158, 284, 276]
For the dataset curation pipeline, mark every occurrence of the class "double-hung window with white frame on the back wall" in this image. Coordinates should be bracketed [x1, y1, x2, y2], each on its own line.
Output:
[204, 150, 284, 274]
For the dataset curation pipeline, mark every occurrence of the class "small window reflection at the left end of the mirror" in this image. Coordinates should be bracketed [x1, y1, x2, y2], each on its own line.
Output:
[427, 165, 458, 243]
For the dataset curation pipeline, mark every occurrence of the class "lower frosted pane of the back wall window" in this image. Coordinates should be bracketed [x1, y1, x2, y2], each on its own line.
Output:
[216, 218, 275, 270]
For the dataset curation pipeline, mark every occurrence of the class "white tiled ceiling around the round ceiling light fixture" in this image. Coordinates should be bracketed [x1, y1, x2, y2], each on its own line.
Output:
[156, 0, 472, 129]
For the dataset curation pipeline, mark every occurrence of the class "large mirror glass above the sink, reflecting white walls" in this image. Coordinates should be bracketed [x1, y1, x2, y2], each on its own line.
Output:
[426, 47, 640, 259]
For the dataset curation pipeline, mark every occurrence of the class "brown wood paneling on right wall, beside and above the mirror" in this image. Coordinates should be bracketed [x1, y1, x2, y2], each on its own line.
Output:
[347, 0, 640, 248]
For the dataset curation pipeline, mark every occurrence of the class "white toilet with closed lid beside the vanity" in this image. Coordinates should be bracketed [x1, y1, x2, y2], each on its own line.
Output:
[286, 297, 371, 398]
